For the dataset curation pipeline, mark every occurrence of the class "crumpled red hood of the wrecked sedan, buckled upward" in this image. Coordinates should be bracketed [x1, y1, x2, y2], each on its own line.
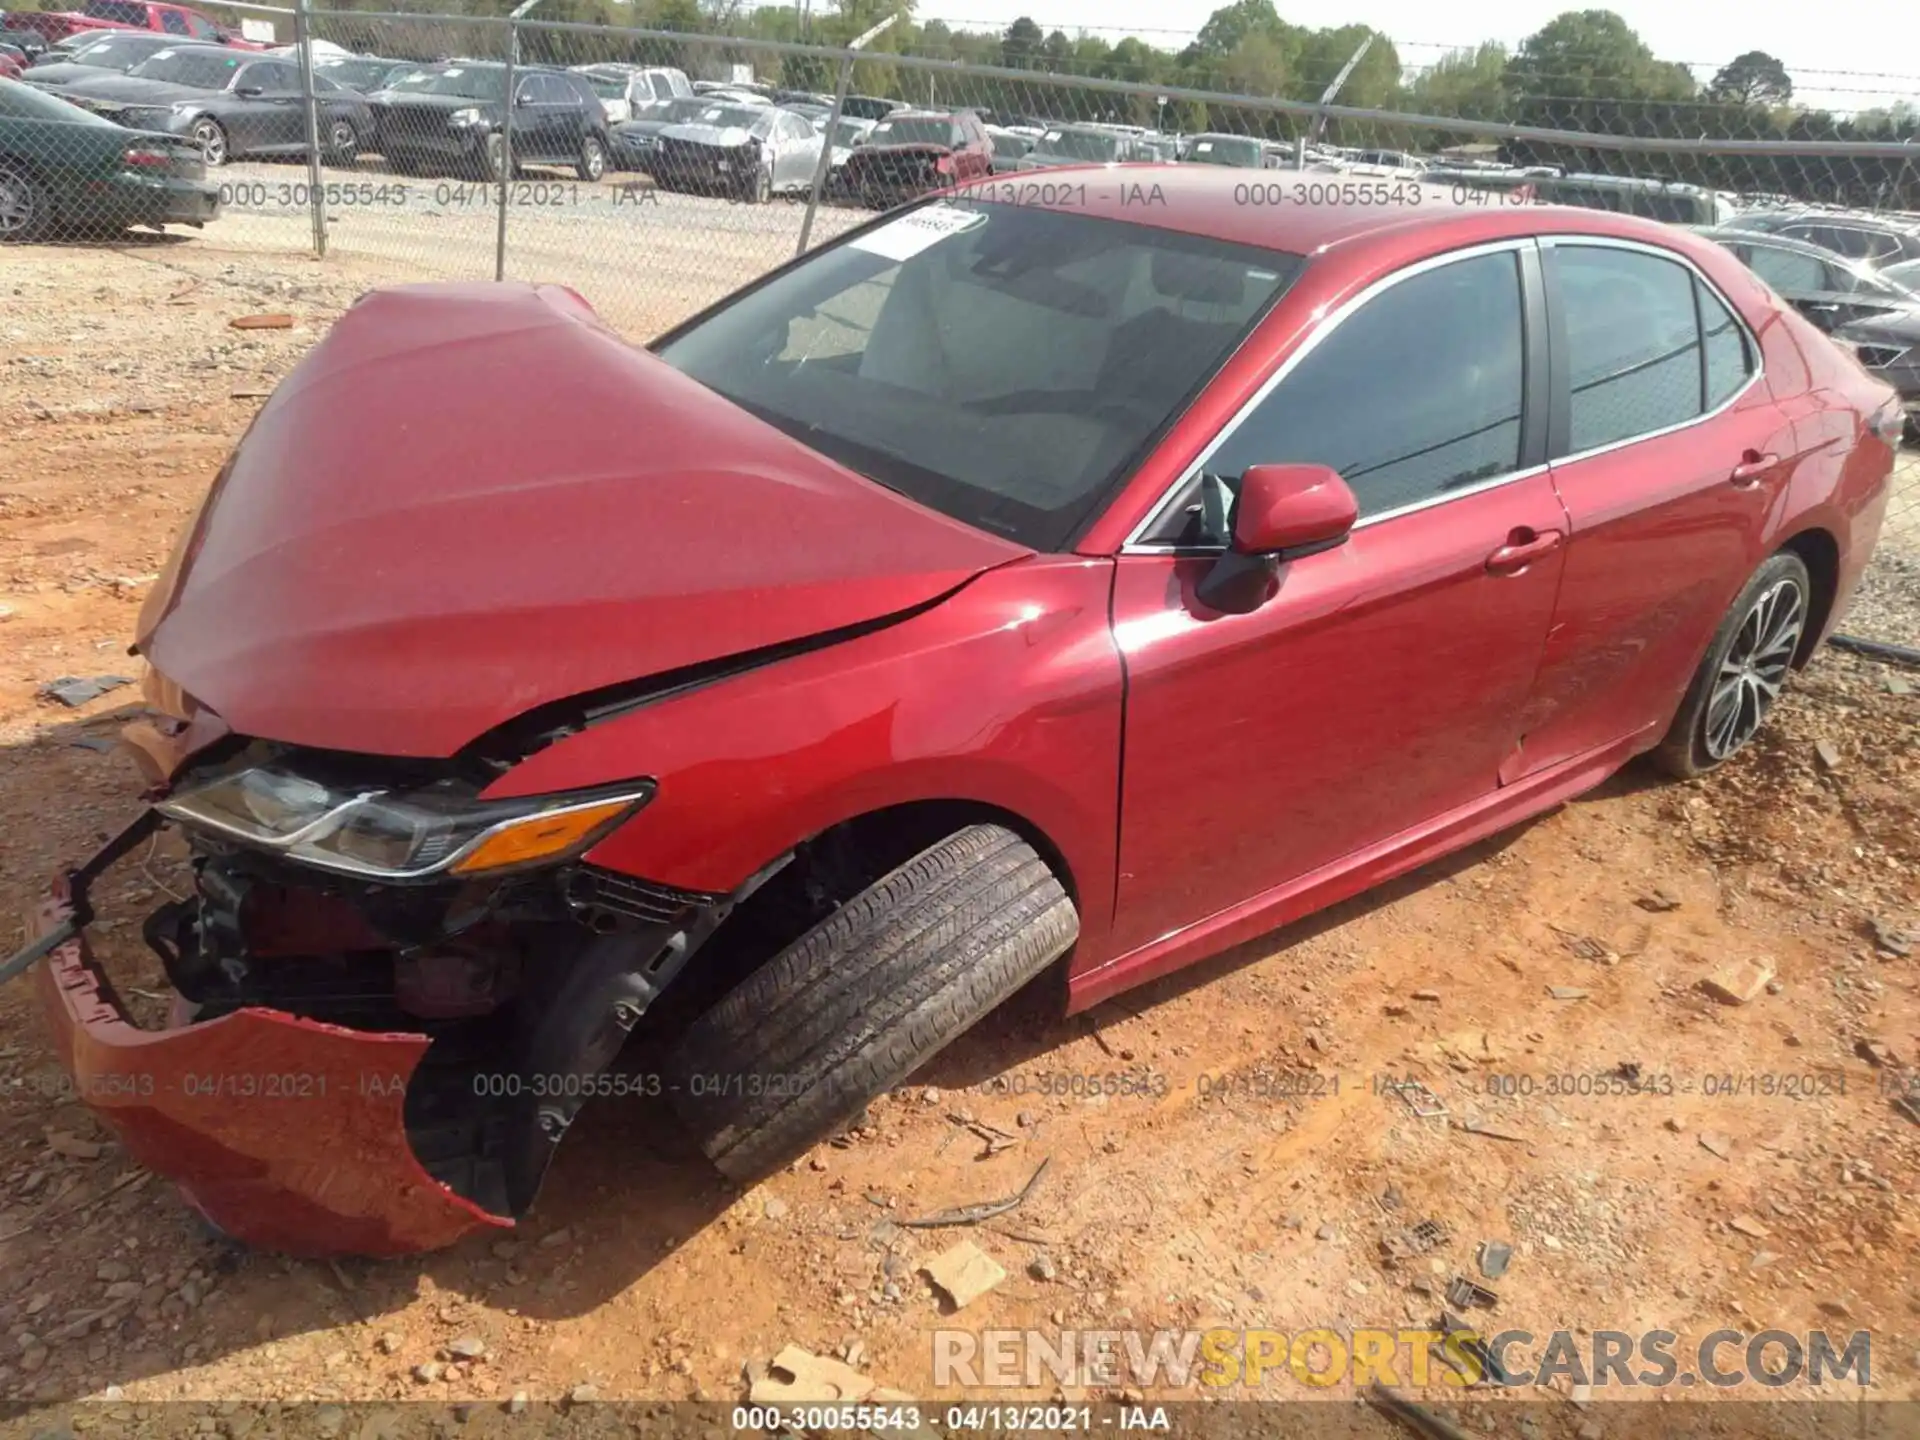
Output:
[140, 284, 1029, 756]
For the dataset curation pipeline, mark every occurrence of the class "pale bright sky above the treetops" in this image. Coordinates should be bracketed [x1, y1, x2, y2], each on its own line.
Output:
[914, 0, 1920, 111]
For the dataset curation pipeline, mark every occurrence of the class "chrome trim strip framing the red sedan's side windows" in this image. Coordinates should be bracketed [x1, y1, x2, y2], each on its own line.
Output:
[1119, 234, 1766, 555]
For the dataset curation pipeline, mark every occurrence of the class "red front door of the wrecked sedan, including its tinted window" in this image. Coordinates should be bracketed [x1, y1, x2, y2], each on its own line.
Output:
[1114, 240, 1567, 952]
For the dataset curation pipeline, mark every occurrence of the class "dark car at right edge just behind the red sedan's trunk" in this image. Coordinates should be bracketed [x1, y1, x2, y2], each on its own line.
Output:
[1701, 227, 1920, 440]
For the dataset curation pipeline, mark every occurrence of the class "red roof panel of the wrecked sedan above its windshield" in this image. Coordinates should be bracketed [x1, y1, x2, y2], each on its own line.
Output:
[960, 163, 1738, 265]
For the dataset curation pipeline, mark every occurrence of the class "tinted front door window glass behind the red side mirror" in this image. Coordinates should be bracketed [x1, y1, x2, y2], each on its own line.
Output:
[1204, 252, 1528, 518]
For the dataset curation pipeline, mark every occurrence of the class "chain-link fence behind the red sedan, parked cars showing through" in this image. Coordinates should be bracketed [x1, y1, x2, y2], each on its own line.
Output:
[0, 4, 1920, 647]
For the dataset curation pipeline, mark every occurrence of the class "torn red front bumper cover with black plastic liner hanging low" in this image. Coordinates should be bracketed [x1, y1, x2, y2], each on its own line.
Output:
[8, 812, 732, 1256]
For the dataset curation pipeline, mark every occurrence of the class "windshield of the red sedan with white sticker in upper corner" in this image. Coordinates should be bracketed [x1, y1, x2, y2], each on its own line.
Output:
[659, 202, 1302, 549]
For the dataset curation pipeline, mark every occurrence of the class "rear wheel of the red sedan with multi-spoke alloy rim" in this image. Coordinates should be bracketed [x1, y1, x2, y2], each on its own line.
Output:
[1653, 551, 1812, 780]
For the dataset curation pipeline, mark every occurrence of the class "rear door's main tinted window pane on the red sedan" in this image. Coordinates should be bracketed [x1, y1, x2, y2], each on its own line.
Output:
[1548, 246, 1703, 455]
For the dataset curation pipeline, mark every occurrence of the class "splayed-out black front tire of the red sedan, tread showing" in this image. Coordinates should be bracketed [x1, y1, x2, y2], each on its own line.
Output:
[668, 826, 1079, 1183]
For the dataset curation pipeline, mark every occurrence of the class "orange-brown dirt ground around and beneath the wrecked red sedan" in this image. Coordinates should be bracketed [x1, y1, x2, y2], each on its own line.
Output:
[0, 240, 1920, 1436]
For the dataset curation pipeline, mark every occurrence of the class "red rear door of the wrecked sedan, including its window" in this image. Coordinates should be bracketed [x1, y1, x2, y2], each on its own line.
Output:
[1509, 236, 1795, 778]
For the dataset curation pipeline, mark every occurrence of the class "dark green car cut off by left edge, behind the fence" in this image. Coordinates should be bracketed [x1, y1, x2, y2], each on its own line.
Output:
[0, 81, 221, 240]
